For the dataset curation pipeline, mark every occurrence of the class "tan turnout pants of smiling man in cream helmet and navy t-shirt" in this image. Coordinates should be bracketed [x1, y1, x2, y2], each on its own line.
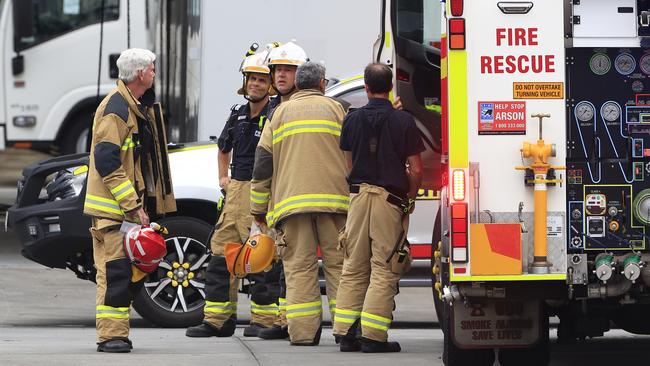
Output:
[203, 180, 281, 328]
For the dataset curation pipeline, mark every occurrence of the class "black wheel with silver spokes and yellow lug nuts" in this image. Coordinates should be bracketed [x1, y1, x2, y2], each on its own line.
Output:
[133, 216, 212, 328]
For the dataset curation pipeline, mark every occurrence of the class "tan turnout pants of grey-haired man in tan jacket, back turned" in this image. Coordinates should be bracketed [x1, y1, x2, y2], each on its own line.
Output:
[278, 213, 345, 343]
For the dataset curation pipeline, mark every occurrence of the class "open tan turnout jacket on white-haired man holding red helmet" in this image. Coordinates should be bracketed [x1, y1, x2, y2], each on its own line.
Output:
[84, 81, 176, 221]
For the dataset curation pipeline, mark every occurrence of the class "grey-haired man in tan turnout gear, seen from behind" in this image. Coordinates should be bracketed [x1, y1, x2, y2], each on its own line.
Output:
[251, 62, 349, 346]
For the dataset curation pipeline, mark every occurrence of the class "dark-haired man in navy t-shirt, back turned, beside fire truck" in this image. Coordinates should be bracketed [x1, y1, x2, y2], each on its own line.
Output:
[334, 63, 424, 352]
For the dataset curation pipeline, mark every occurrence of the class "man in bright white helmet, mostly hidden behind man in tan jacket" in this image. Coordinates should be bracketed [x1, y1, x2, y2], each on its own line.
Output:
[258, 42, 308, 339]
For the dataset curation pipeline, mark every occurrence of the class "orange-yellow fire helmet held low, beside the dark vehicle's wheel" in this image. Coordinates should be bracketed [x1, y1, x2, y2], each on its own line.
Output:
[224, 234, 275, 278]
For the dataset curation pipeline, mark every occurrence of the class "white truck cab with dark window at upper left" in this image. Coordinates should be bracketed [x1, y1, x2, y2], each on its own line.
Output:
[0, 0, 146, 153]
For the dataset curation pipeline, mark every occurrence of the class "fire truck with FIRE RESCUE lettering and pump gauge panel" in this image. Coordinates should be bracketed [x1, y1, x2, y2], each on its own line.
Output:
[433, 0, 650, 366]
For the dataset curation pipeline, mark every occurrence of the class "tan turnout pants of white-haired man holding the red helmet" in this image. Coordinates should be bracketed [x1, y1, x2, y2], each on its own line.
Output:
[90, 219, 144, 342]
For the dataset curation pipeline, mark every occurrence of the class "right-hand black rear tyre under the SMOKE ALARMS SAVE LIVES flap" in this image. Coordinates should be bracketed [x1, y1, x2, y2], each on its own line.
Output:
[499, 314, 551, 366]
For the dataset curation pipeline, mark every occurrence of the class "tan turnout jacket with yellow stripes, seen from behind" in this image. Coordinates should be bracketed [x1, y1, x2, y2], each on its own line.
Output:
[251, 90, 349, 226]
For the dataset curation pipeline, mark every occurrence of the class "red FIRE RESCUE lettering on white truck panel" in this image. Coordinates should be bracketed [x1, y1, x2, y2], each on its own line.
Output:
[481, 28, 555, 74]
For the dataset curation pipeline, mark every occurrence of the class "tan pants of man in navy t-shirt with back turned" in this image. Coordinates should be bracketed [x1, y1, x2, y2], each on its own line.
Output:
[334, 184, 402, 342]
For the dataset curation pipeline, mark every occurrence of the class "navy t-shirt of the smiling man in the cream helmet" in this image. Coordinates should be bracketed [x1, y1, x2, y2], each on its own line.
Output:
[217, 99, 270, 181]
